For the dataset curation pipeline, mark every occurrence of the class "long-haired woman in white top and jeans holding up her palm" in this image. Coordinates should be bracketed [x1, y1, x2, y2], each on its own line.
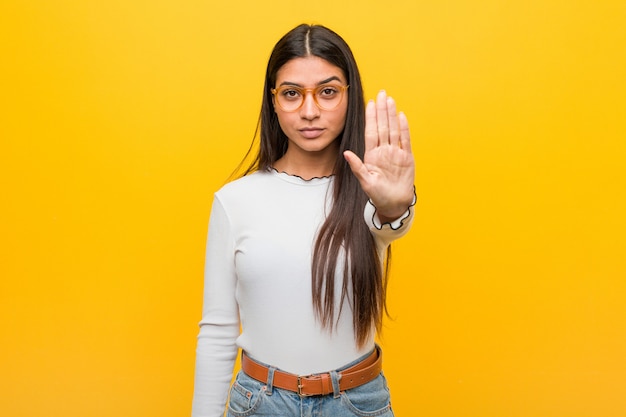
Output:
[193, 25, 415, 417]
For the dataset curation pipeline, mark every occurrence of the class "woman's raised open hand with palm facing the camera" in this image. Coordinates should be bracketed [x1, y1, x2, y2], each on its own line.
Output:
[343, 91, 415, 223]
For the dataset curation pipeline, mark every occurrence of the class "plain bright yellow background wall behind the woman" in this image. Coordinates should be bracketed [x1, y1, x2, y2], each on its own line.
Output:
[0, 0, 626, 417]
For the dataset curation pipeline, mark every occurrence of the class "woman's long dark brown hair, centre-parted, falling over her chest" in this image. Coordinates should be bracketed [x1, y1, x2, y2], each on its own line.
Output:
[236, 24, 391, 346]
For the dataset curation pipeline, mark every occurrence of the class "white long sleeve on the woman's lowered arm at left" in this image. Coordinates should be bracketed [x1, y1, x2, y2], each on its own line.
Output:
[192, 195, 239, 417]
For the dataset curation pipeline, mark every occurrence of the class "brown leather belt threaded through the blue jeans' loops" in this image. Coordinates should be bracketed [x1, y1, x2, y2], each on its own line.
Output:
[241, 345, 383, 397]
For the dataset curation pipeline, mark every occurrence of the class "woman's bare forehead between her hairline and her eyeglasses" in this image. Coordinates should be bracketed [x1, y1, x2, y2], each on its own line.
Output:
[276, 56, 346, 86]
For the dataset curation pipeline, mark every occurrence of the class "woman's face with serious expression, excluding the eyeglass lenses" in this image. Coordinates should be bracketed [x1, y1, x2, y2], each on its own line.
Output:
[274, 56, 348, 155]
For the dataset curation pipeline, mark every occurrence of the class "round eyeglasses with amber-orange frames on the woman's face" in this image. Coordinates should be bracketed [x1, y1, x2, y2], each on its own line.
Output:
[272, 84, 350, 112]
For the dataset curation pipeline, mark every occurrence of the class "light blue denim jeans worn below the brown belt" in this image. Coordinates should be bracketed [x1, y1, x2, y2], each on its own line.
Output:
[228, 350, 393, 417]
